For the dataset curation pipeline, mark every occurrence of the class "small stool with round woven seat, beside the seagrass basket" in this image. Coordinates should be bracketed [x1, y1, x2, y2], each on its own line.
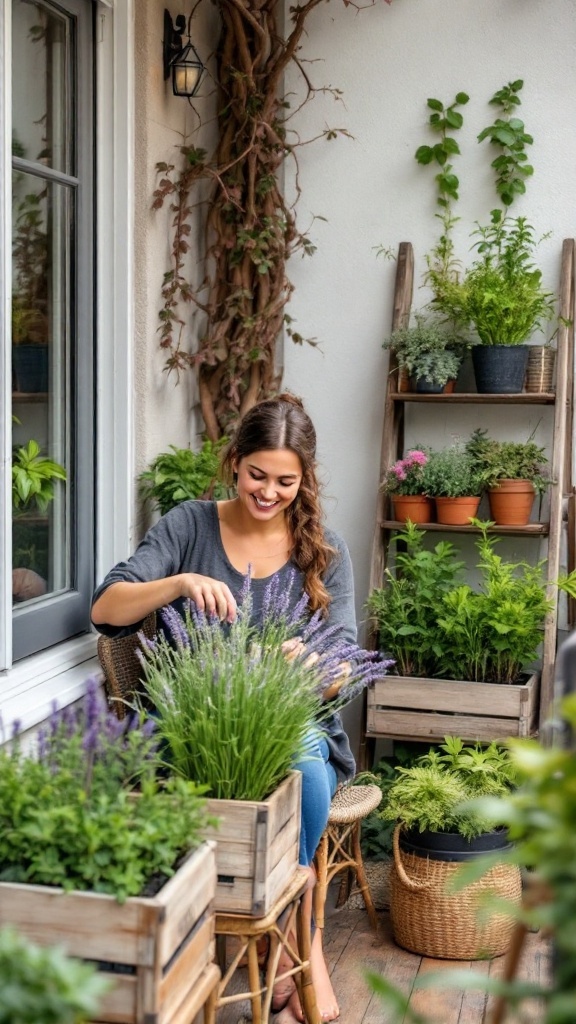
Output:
[314, 785, 382, 931]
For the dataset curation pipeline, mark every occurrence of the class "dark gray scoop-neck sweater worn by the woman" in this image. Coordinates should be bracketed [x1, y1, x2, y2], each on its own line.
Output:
[92, 501, 357, 781]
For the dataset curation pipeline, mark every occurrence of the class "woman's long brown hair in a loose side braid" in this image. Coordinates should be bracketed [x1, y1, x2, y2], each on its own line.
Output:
[221, 391, 337, 613]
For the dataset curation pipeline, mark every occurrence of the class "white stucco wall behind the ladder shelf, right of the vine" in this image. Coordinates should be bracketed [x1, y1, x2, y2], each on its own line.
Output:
[285, 0, 576, 638]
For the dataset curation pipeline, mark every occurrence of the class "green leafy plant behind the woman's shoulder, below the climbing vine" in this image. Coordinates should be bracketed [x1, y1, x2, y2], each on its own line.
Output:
[138, 437, 228, 515]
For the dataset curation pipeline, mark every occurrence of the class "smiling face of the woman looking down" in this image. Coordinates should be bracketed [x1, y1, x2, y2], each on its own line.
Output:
[234, 449, 302, 521]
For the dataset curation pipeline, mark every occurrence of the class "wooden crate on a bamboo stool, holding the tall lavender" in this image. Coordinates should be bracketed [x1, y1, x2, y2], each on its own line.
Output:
[203, 771, 302, 918]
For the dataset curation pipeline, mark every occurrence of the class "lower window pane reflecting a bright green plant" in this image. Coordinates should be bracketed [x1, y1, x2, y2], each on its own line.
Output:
[12, 171, 74, 604]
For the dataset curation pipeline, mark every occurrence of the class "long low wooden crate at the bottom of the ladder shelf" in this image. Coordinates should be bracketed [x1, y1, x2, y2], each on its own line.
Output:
[366, 674, 539, 741]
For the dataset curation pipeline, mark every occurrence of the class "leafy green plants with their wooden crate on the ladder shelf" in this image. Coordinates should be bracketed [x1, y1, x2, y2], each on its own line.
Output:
[367, 520, 576, 739]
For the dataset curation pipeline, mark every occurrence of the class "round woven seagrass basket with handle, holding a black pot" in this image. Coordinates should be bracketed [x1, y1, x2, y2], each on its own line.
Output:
[390, 826, 522, 959]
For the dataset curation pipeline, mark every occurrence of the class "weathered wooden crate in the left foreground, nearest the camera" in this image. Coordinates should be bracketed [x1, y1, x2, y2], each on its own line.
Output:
[0, 842, 216, 1024]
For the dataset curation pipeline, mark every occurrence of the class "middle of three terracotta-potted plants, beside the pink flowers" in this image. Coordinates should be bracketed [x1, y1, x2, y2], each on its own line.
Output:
[423, 442, 483, 526]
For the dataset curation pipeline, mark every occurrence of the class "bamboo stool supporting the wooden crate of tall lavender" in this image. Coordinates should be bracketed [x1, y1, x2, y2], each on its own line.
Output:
[216, 868, 320, 1024]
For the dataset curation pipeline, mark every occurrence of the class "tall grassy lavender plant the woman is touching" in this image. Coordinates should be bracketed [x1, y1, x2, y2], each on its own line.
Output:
[142, 574, 390, 800]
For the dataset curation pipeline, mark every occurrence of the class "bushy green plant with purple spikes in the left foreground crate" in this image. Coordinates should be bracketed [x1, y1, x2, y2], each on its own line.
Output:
[0, 680, 208, 902]
